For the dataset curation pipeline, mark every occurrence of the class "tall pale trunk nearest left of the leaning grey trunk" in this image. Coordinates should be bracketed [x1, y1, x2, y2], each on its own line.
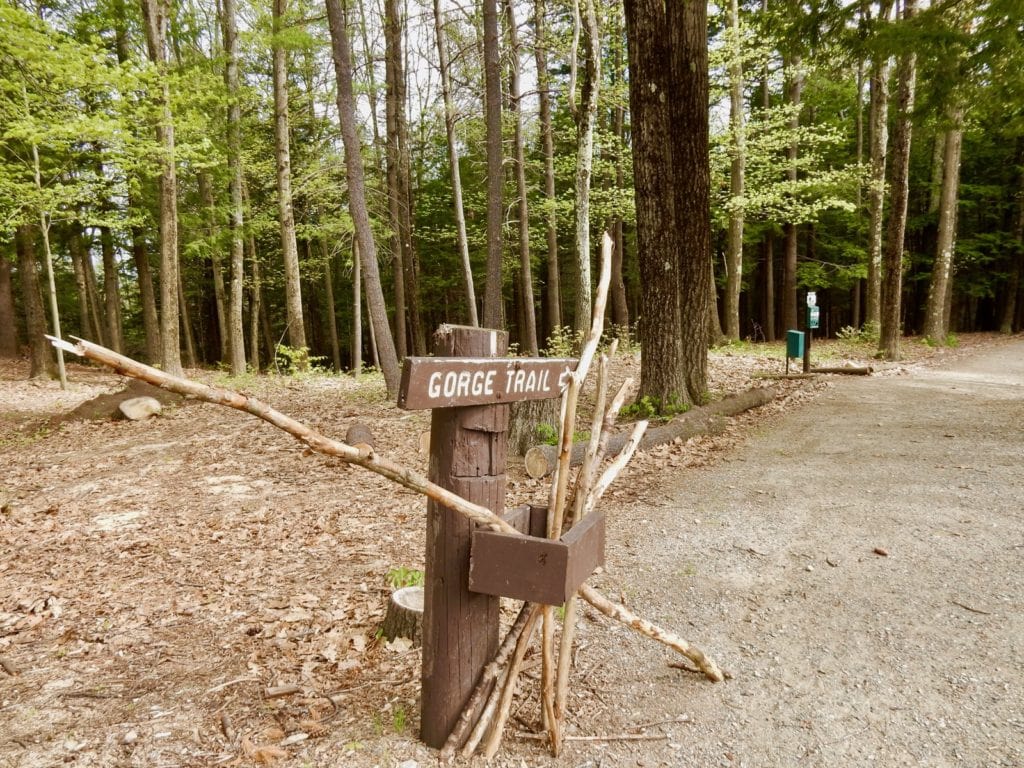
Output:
[271, 0, 306, 356]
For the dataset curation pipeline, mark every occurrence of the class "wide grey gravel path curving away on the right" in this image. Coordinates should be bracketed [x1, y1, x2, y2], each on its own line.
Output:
[509, 341, 1024, 766]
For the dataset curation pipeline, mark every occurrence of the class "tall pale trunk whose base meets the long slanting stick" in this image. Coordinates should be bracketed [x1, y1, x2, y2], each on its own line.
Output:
[141, 0, 181, 376]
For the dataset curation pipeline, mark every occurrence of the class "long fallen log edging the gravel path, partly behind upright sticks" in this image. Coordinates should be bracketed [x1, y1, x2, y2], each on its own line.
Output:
[525, 387, 776, 478]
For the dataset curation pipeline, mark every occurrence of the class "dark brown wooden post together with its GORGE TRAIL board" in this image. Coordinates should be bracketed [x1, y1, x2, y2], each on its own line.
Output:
[398, 326, 575, 749]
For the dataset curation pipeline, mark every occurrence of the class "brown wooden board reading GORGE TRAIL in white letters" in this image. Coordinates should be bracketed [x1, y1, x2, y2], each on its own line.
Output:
[398, 357, 577, 411]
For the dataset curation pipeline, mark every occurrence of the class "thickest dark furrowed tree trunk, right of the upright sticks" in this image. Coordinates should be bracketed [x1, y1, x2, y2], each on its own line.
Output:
[626, 0, 711, 404]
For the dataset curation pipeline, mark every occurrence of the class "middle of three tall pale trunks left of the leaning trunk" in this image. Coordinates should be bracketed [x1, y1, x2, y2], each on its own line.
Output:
[221, 0, 246, 376]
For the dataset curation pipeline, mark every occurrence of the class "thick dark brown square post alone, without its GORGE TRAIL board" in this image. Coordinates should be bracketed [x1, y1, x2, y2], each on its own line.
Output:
[420, 326, 509, 749]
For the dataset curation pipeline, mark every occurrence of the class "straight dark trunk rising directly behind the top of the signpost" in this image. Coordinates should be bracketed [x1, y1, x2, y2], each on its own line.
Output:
[483, 0, 505, 328]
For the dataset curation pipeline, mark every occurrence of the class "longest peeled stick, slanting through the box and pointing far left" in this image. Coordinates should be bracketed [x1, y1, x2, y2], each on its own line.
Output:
[46, 336, 722, 681]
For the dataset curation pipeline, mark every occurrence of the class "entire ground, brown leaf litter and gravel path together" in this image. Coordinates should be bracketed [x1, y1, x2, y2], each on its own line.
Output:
[0, 335, 1024, 768]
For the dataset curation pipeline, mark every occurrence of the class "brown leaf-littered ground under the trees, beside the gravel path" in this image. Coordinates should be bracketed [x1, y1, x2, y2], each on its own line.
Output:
[0, 335, 1004, 768]
